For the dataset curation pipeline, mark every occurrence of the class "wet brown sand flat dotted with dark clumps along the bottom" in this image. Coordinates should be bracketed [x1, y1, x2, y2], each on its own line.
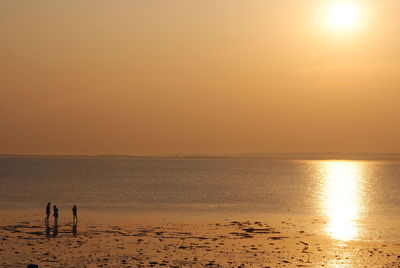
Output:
[0, 213, 400, 267]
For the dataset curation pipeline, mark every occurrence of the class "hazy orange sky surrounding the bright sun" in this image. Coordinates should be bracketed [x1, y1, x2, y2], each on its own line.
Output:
[0, 0, 400, 154]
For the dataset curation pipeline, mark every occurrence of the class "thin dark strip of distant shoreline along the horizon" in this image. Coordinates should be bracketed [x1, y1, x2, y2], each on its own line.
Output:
[0, 153, 400, 160]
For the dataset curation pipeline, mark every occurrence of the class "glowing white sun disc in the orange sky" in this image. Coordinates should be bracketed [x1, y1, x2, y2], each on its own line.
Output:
[326, 1, 361, 31]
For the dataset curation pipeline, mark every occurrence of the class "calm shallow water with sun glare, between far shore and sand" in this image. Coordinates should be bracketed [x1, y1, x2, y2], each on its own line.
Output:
[0, 157, 400, 240]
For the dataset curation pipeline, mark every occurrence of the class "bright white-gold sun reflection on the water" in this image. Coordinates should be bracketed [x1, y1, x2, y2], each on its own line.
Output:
[321, 161, 362, 241]
